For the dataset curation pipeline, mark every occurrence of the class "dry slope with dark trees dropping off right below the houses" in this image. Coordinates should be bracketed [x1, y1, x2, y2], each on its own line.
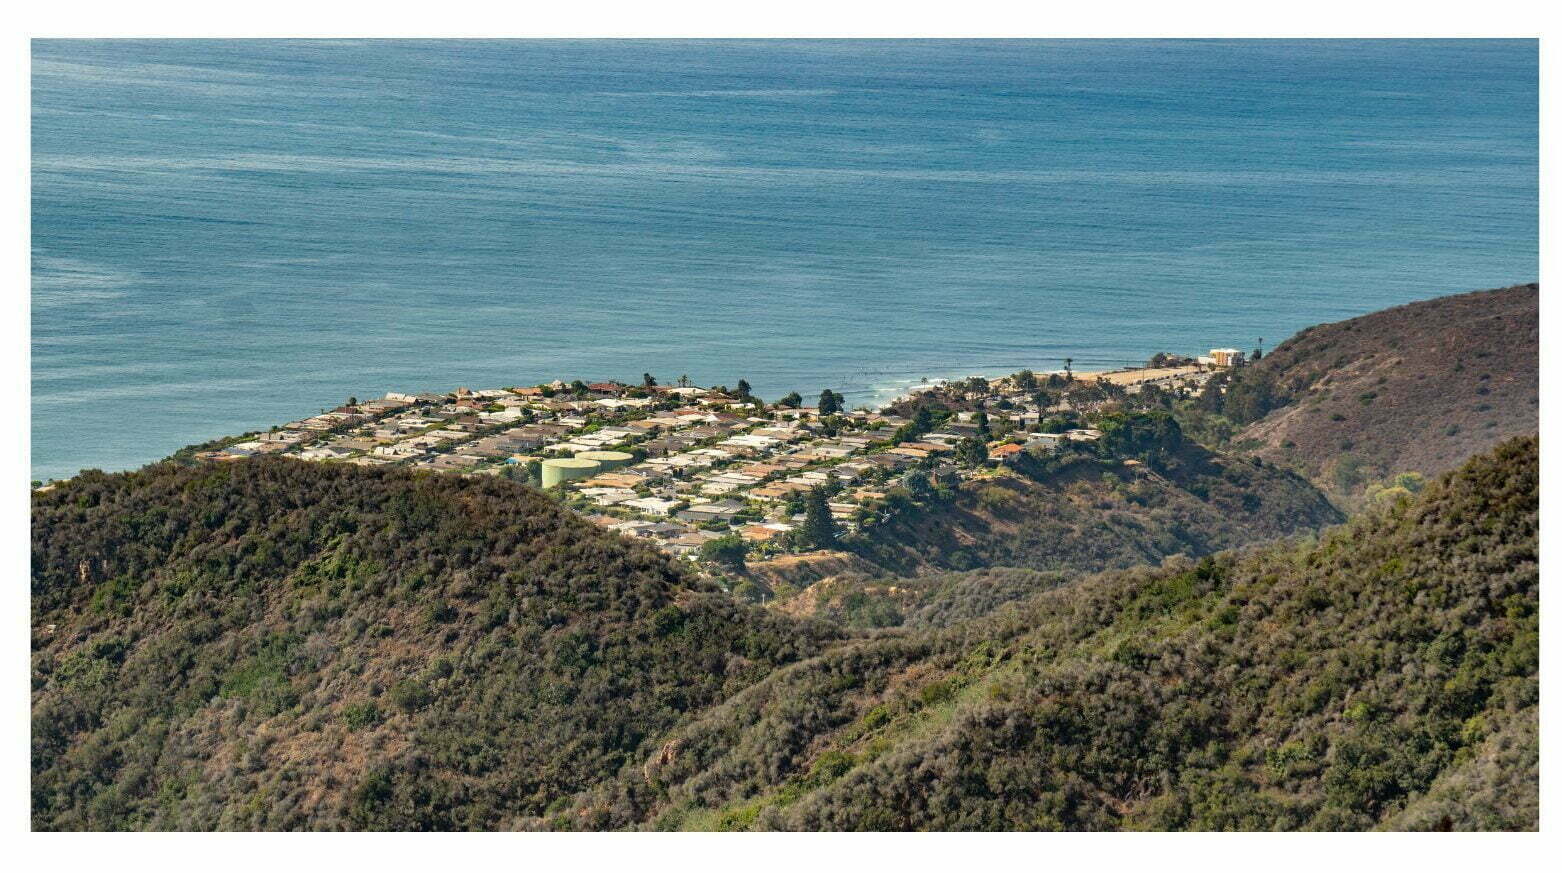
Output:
[853, 440, 1345, 575]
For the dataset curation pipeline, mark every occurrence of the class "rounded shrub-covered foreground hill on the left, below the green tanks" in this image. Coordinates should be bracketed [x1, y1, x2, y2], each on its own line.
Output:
[33, 459, 836, 829]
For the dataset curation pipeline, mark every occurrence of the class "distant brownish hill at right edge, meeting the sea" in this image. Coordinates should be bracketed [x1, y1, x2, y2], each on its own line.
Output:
[1220, 284, 1540, 498]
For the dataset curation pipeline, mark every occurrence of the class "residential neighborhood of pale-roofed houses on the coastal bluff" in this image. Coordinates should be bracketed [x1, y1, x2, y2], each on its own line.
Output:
[185, 356, 1240, 574]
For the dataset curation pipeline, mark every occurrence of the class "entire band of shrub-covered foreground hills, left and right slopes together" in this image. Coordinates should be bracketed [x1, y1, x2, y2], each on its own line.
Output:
[33, 437, 1539, 829]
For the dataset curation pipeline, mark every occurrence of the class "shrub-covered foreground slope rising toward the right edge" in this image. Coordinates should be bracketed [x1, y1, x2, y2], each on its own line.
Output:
[587, 439, 1539, 829]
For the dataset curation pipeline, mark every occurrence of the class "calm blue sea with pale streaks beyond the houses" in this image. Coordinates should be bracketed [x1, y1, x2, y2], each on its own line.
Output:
[31, 41, 1539, 478]
